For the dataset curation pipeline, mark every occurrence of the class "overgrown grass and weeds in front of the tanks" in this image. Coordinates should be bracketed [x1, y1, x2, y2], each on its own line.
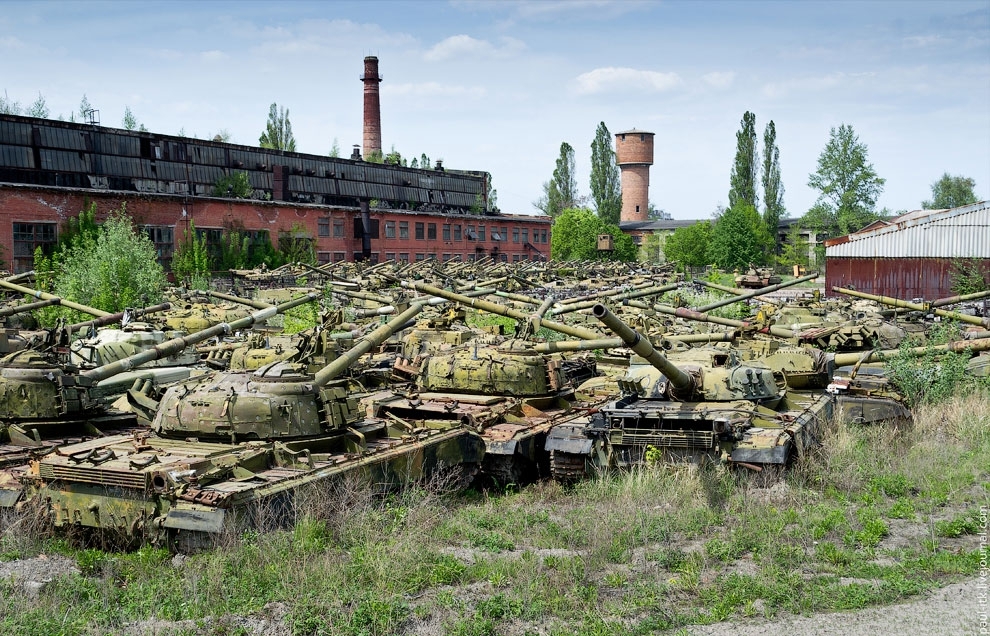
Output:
[0, 393, 990, 635]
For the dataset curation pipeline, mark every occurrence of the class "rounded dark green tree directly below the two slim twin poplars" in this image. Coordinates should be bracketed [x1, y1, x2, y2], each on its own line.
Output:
[707, 202, 773, 270]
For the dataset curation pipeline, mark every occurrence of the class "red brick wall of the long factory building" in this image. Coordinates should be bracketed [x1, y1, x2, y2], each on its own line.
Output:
[0, 184, 551, 269]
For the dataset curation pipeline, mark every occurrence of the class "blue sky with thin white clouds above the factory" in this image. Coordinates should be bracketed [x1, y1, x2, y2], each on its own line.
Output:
[0, 0, 990, 220]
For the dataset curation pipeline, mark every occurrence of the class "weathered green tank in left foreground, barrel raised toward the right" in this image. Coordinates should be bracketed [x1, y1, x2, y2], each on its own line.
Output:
[9, 305, 484, 550]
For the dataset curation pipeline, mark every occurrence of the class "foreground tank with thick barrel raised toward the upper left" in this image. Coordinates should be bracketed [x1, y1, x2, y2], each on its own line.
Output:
[546, 305, 834, 480]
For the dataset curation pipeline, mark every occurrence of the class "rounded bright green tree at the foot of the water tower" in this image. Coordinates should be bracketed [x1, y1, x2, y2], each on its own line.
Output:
[550, 208, 637, 261]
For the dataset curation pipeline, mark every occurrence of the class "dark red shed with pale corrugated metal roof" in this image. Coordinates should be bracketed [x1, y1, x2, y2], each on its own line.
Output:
[825, 201, 990, 300]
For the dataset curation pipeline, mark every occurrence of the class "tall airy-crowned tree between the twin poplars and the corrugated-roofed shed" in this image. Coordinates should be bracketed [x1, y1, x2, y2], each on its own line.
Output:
[805, 124, 886, 235]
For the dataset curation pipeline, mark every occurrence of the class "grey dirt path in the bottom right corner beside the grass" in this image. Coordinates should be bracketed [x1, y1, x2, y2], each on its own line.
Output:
[687, 579, 990, 636]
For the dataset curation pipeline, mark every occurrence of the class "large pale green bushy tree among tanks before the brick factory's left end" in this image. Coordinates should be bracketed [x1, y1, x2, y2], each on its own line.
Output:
[54, 206, 165, 312]
